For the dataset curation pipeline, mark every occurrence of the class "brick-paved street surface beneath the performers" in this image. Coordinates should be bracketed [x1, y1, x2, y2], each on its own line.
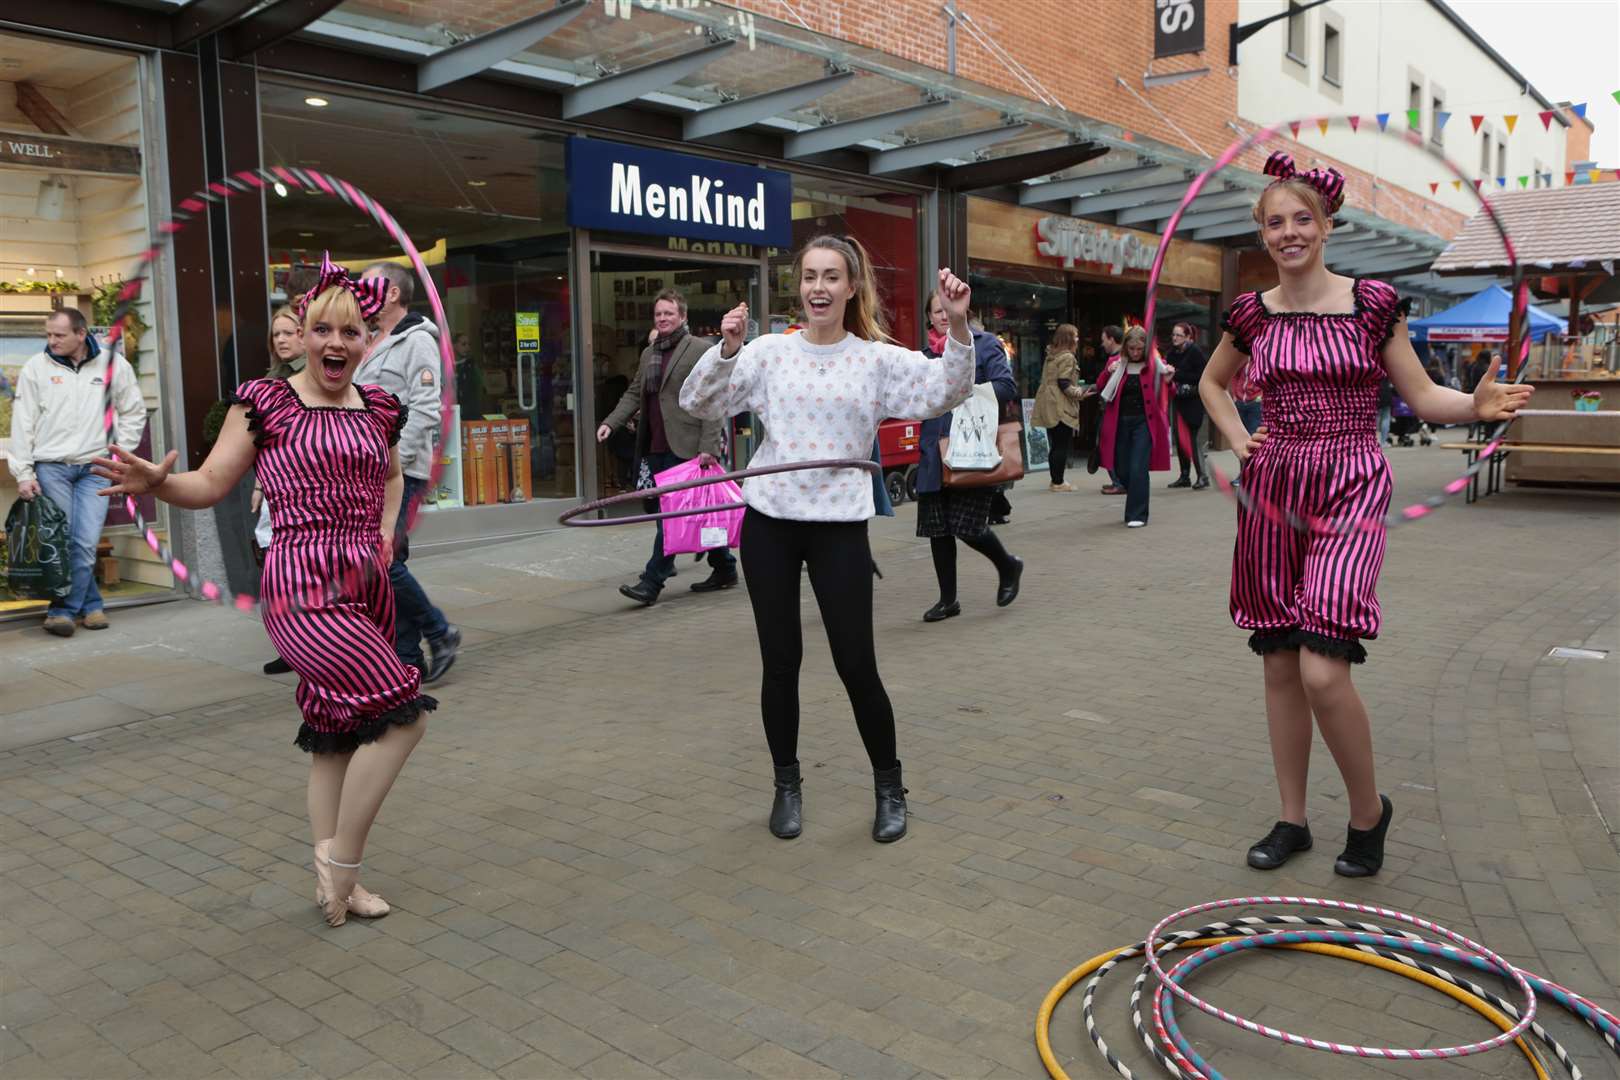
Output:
[0, 450, 1620, 1080]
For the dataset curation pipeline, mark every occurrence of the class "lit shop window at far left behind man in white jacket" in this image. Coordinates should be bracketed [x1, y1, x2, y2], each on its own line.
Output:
[0, 34, 173, 615]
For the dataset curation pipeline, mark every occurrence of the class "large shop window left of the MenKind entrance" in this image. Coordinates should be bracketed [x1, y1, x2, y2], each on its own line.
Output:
[260, 83, 576, 510]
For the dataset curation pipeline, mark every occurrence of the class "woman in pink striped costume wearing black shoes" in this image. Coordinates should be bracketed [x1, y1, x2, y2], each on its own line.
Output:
[1199, 152, 1531, 878]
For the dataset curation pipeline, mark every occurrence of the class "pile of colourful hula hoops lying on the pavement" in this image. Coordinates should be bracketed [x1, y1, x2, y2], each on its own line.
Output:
[1035, 895, 1620, 1080]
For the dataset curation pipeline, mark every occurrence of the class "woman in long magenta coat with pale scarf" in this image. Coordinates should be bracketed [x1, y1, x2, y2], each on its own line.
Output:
[1097, 325, 1175, 529]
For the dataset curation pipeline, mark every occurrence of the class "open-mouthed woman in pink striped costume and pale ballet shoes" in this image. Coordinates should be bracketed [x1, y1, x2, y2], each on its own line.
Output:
[97, 261, 437, 926]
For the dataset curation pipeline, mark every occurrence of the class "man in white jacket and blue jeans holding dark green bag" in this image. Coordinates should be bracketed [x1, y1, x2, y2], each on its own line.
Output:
[6, 308, 146, 638]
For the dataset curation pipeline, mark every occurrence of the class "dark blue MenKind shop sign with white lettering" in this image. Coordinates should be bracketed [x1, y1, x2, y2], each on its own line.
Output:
[569, 136, 794, 248]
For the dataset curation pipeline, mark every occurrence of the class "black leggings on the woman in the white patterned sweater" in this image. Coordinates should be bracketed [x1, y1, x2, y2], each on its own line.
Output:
[739, 507, 897, 769]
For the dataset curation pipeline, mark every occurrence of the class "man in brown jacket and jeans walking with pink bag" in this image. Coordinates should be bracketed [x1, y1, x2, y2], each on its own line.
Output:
[596, 288, 737, 607]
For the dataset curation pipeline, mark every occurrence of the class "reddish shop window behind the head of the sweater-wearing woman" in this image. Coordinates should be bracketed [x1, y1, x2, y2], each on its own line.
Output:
[760, 176, 930, 348]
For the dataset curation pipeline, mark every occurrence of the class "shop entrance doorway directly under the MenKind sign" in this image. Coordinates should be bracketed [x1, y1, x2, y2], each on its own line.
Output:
[580, 244, 761, 513]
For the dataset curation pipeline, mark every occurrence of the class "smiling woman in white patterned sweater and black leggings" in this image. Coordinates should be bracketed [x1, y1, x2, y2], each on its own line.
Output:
[680, 236, 974, 844]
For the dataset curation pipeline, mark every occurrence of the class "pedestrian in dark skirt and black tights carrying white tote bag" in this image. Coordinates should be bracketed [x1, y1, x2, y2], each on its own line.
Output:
[917, 288, 1023, 622]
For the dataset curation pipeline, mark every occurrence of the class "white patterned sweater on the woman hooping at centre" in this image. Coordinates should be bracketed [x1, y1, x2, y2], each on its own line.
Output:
[680, 334, 974, 521]
